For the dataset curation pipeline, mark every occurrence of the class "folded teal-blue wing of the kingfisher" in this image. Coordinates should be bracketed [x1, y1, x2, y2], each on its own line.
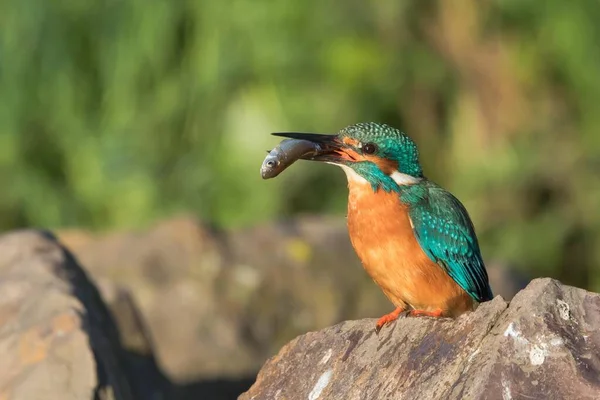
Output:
[409, 184, 493, 303]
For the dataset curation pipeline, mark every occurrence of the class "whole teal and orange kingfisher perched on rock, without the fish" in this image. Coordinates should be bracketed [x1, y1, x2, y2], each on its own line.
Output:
[273, 122, 493, 333]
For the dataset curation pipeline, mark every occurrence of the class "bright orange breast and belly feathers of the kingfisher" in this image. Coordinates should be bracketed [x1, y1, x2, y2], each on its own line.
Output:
[348, 181, 473, 316]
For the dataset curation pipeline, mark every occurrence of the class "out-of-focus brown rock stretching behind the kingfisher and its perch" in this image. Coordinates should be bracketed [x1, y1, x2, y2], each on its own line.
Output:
[59, 217, 524, 382]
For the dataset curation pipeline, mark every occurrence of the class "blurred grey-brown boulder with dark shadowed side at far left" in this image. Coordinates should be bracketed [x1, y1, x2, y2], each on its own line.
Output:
[0, 231, 140, 400]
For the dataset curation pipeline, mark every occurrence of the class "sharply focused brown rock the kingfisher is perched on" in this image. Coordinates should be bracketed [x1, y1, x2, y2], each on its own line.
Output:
[240, 278, 600, 400]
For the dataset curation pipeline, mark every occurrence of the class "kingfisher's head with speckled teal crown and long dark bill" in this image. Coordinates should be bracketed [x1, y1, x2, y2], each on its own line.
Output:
[274, 122, 423, 191]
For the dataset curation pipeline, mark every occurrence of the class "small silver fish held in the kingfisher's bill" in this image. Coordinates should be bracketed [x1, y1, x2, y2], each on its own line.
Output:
[260, 139, 321, 179]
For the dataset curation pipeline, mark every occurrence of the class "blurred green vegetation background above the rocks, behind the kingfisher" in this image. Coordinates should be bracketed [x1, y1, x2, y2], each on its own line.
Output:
[0, 0, 600, 290]
